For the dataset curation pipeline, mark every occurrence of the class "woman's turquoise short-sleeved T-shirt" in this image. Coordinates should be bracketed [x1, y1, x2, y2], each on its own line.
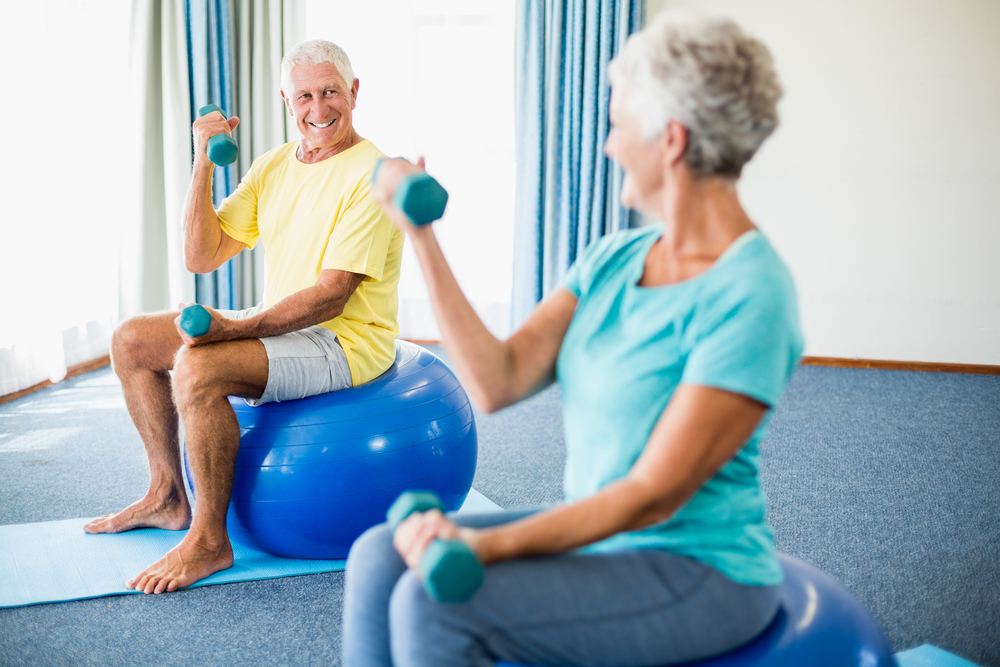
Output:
[556, 225, 802, 585]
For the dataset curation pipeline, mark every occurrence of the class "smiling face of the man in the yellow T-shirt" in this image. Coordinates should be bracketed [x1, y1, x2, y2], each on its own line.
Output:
[281, 63, 358, 150]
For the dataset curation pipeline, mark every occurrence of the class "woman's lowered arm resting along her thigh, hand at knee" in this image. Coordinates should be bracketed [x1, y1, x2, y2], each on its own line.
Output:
[396, 385, 768, 565]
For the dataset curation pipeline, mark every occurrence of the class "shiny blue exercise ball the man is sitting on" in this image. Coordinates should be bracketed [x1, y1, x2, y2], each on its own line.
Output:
[185, 341, 477, 559]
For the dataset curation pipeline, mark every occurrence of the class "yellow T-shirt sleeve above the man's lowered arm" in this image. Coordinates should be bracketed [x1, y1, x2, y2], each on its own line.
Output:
[321, 176, 396, 280]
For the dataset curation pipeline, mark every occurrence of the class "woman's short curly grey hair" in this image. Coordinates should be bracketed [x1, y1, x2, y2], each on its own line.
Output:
[608, 11, 782, 177]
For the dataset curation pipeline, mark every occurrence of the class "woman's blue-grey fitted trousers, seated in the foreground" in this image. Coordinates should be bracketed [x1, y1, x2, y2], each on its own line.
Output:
[343, 510, 778, 667]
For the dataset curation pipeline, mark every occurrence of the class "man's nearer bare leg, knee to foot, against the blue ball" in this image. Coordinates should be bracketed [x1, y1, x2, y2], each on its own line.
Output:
[126, 339, 268, 593]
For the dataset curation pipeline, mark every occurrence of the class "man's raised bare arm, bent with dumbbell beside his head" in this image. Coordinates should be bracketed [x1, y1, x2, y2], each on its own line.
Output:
[184, 111, 246, 273]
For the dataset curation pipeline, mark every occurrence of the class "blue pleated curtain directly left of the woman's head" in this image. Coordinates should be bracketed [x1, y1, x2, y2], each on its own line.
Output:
[512, 0, 645, 327]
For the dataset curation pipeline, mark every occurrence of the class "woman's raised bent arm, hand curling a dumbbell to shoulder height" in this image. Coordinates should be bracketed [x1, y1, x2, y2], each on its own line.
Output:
[373, 160, 576, 412]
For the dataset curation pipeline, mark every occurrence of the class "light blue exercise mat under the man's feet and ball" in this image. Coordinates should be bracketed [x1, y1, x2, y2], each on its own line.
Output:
[0, 489, 499, 608]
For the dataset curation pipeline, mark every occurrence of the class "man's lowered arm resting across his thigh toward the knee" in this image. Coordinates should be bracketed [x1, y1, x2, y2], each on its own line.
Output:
[177, 269, 365, 347]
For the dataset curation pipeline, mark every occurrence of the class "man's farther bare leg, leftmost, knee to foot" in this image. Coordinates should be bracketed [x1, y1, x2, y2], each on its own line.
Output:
[83, 312, 191, 533]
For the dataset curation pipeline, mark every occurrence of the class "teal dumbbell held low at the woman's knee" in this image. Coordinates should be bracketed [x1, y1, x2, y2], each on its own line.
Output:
[386, 491, 483, 602]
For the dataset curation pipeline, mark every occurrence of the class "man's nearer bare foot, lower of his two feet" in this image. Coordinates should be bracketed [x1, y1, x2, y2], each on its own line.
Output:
[125, 533, 233, 594]
